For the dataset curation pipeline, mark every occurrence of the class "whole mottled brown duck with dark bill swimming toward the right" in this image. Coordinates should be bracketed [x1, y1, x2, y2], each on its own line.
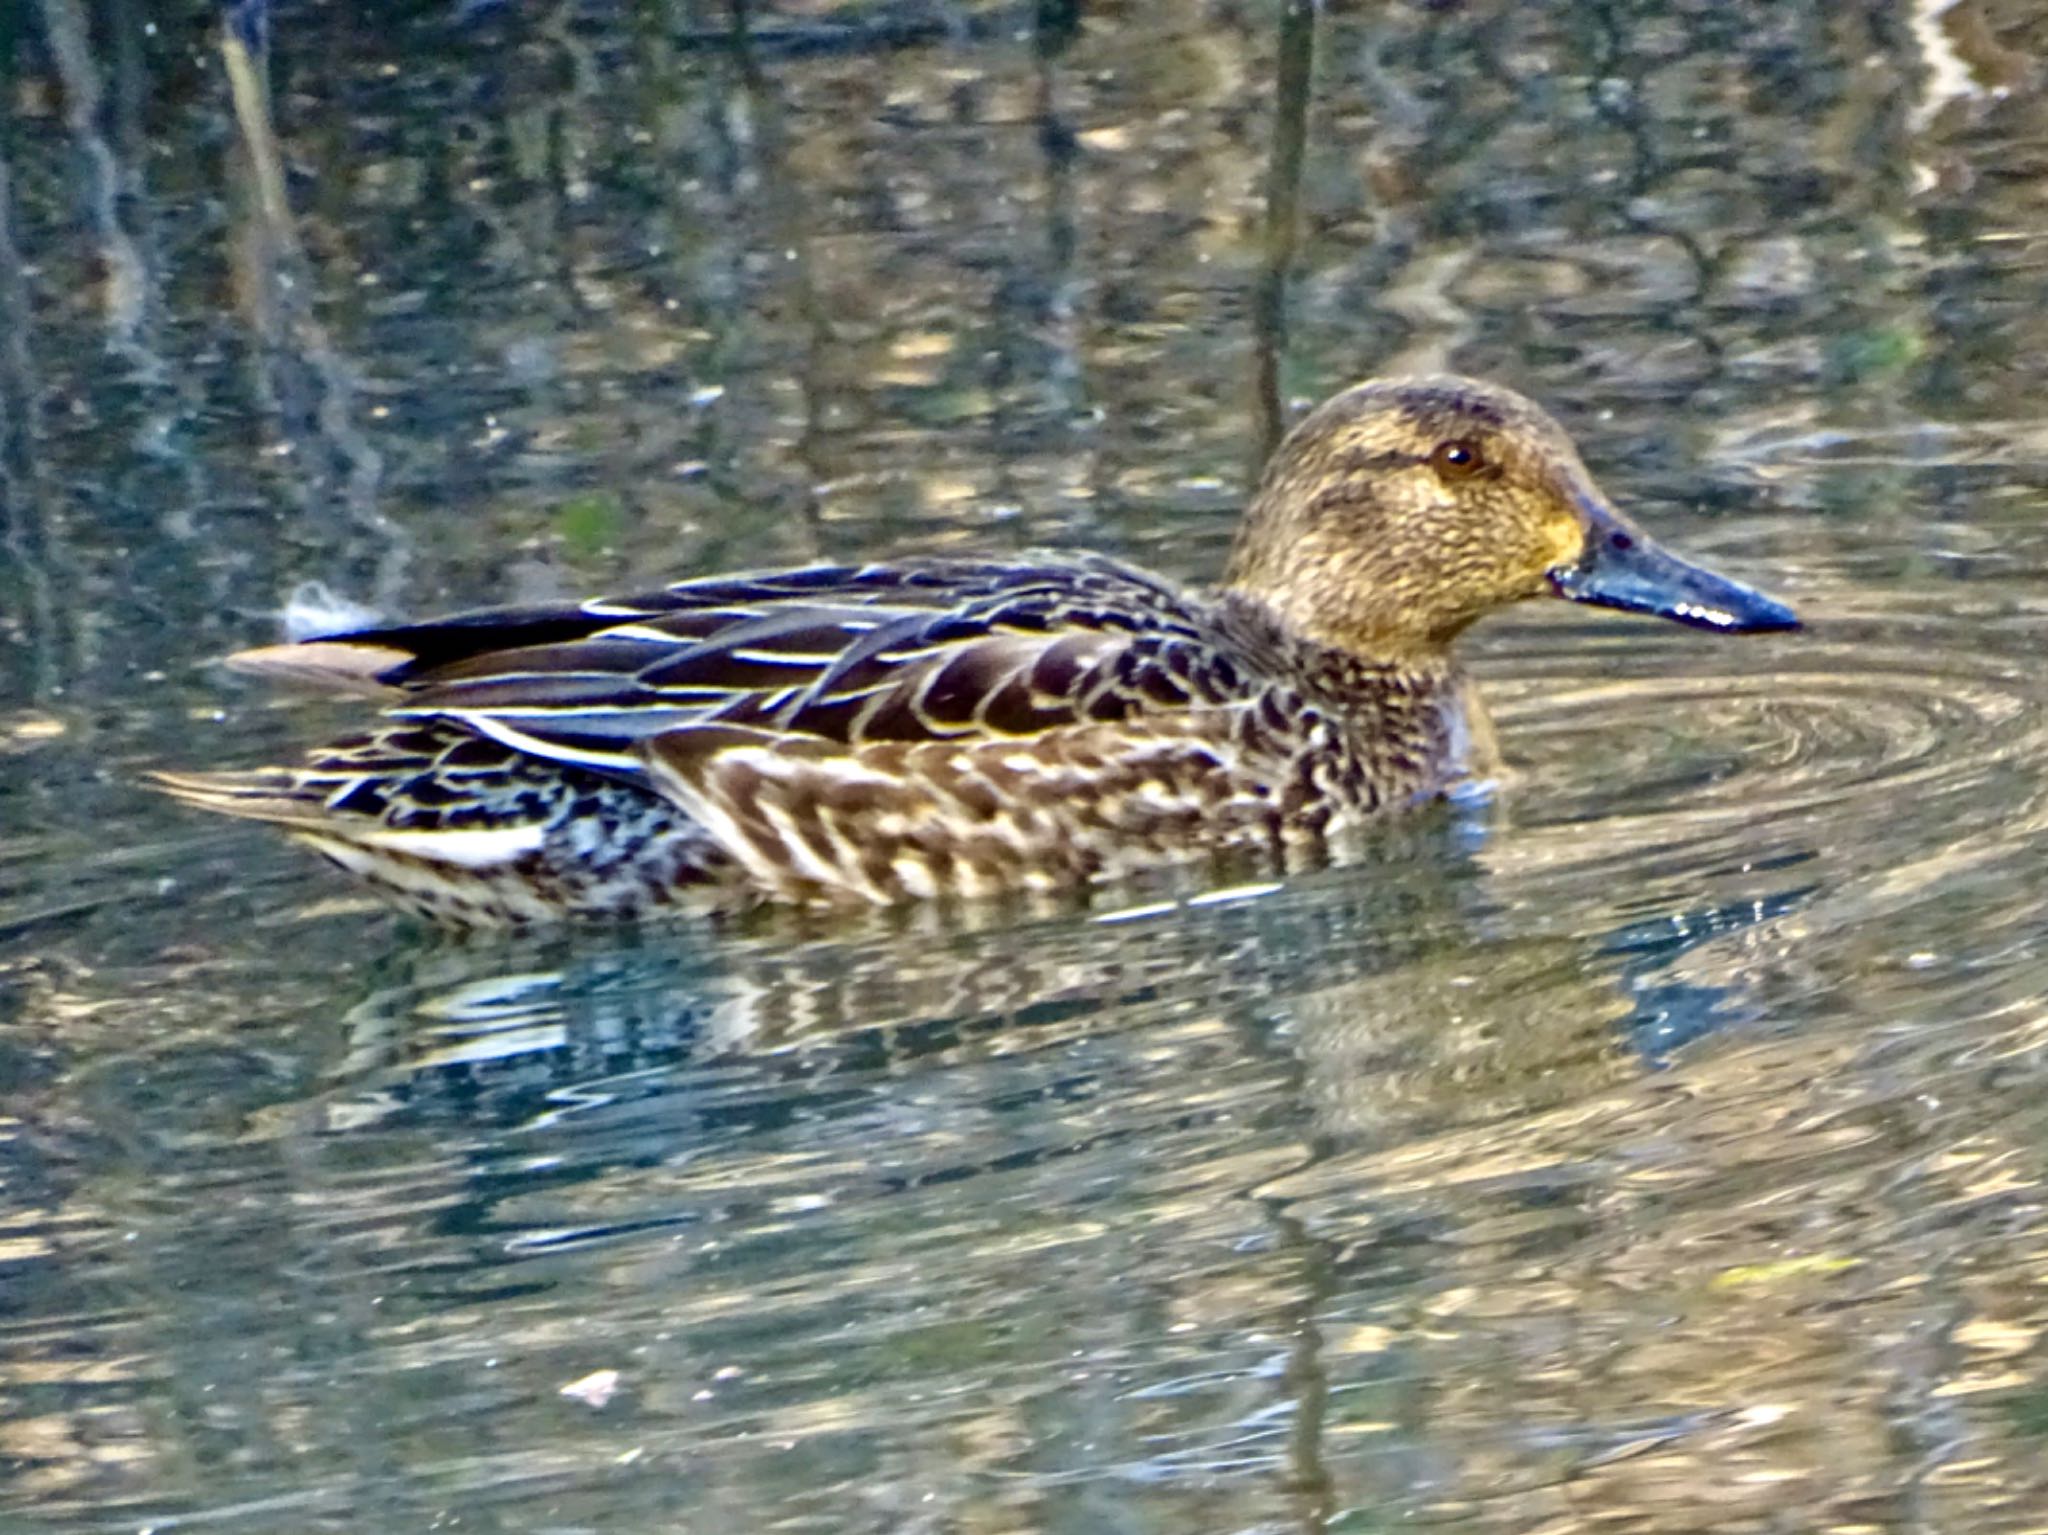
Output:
[156, 377, 1798, 927]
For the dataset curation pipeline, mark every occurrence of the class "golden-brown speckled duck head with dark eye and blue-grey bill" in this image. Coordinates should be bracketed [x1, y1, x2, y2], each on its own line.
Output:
[1227, 377, 1798, 655]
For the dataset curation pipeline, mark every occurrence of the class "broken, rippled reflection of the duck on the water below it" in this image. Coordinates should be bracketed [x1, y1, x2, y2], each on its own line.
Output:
[319, 835, 1800, 1156]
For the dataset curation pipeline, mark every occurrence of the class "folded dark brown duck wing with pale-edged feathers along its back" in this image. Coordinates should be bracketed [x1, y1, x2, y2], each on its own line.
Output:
[236, 555, 1255, 778]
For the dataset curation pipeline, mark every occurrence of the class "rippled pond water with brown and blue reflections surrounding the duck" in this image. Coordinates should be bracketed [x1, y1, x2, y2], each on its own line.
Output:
[0, 0, 2048, 1535]
